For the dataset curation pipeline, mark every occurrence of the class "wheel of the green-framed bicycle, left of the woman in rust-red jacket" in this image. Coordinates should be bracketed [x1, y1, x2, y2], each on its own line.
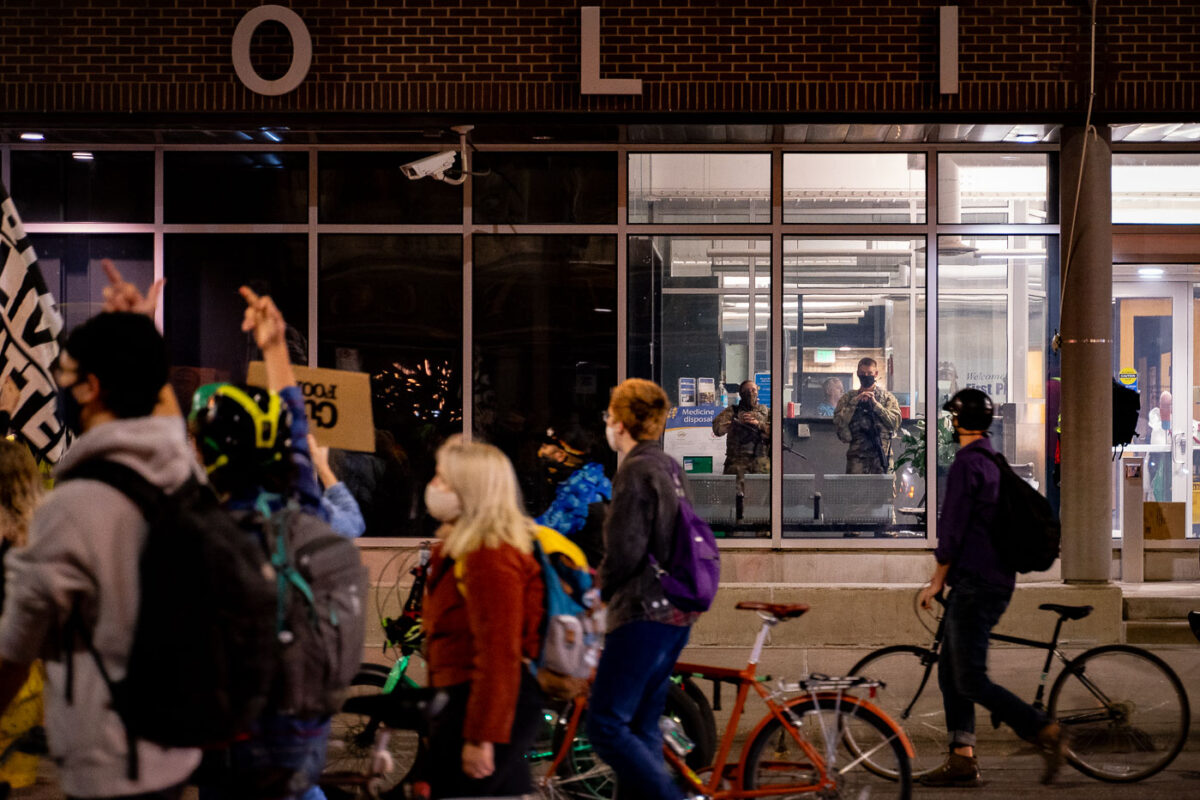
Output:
[319, 664, 420, 800]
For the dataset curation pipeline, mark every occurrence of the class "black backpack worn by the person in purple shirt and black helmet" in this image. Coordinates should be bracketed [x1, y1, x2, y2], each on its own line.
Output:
[983, 451, 1062, 572]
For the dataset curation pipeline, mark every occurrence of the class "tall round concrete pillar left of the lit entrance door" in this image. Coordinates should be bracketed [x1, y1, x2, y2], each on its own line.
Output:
[1048, 126, 1112, 583]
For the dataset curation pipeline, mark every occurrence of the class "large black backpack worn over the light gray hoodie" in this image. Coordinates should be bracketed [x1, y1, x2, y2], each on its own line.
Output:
[60, 461, 277, 780]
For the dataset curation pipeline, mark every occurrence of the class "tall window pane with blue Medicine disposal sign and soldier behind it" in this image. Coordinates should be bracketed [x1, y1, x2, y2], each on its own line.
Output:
[629, 236, 772, 537]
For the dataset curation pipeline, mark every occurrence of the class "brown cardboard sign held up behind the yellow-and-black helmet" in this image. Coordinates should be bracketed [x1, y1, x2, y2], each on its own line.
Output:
[246, 361, 374, 452]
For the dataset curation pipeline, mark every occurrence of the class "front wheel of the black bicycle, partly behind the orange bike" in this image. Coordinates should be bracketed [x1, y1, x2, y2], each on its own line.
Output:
[850, 644, 948, 777]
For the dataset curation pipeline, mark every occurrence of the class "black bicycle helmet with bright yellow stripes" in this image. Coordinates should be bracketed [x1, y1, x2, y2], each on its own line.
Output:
[187, 384, 292, 477]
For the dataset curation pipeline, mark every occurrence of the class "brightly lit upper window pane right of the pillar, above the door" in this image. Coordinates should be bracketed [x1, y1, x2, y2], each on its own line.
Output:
[1112, 152, 1200, 224]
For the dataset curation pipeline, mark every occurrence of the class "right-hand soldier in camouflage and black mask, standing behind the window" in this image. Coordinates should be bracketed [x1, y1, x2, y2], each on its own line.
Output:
[833, 359, 900, 475]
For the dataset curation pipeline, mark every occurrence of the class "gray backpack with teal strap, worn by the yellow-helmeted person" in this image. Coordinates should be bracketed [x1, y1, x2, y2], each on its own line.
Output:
[234, 506, 367, 717]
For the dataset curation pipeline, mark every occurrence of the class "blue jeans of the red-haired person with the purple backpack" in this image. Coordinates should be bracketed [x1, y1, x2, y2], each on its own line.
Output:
[588, 620, 691, 800]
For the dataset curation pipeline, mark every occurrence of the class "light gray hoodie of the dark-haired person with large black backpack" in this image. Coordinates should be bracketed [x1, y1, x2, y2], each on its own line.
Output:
[0, 417, 200, 798]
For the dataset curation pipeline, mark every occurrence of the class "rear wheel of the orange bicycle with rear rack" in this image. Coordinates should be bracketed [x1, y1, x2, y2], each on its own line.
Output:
[742, 694, 912, 800]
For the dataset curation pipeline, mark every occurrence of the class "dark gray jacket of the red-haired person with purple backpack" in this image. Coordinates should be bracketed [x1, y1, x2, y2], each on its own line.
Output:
[599, 441, 690, 631]
